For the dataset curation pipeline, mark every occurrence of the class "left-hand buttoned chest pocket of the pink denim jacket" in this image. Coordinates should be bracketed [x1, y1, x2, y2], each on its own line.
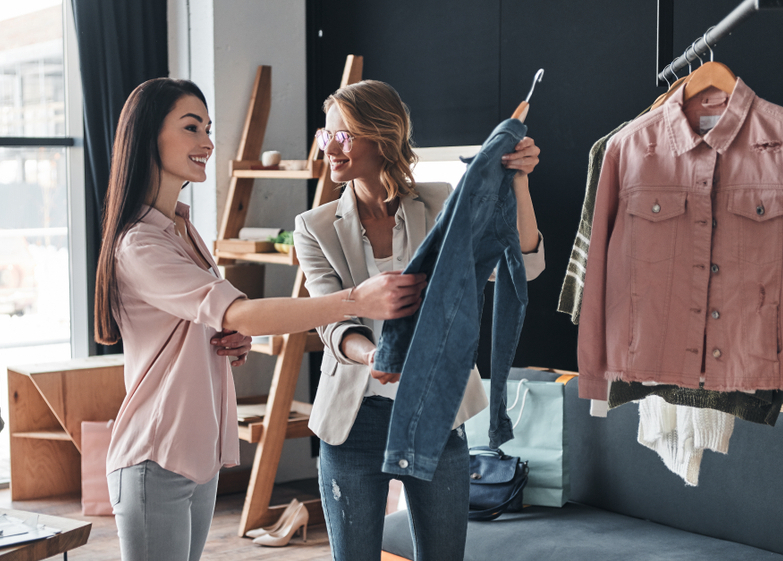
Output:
[626, 191, 686, 263]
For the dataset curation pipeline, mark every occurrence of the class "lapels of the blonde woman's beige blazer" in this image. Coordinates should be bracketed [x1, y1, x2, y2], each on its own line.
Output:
[334, 184, 427, 285]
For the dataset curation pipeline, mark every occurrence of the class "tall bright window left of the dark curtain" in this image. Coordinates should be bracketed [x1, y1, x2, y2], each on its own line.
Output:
[0, 0, 87, 482]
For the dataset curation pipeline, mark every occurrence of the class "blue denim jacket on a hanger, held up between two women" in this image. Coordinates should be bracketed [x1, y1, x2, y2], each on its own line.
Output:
[374, 119, 527, 481]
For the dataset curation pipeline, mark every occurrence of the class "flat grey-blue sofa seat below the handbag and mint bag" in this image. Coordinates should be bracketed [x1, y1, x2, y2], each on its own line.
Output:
[383, 503, 783, 561]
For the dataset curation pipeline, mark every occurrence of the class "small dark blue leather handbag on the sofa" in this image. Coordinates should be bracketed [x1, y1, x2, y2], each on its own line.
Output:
[468, 446, 528, 520]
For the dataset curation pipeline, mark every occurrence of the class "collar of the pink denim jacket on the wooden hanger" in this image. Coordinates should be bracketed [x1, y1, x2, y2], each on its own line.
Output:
[663, 78, 756, 156]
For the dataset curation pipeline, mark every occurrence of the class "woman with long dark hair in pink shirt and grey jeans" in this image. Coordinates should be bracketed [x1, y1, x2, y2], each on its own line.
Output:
[95, 78, 423, 561]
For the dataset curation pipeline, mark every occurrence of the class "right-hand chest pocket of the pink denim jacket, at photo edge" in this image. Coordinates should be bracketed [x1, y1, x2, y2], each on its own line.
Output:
[727, 189, 783, 264]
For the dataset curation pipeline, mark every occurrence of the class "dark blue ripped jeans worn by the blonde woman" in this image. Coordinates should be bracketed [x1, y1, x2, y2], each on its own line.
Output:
[318, 396, 470, 561]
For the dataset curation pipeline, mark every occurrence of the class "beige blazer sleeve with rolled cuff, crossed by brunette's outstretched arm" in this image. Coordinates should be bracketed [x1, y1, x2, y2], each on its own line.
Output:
[294, 212, 373, 365]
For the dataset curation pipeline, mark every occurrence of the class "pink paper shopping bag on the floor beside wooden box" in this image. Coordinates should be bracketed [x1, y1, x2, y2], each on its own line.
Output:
[82, 421, 113, 516]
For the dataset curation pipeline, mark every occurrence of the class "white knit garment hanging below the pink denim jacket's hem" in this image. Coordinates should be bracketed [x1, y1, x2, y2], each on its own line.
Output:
[637, 395, 734, 487]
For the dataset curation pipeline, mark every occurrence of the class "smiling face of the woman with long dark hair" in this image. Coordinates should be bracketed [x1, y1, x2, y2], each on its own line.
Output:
[158, 95, 215, 185]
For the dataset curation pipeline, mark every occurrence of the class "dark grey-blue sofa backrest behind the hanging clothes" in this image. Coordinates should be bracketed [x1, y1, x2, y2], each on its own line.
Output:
[565, 378, 783, 553]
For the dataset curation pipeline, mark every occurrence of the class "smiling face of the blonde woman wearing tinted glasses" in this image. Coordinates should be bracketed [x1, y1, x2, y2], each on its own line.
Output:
[324, 103, 383, 189]
